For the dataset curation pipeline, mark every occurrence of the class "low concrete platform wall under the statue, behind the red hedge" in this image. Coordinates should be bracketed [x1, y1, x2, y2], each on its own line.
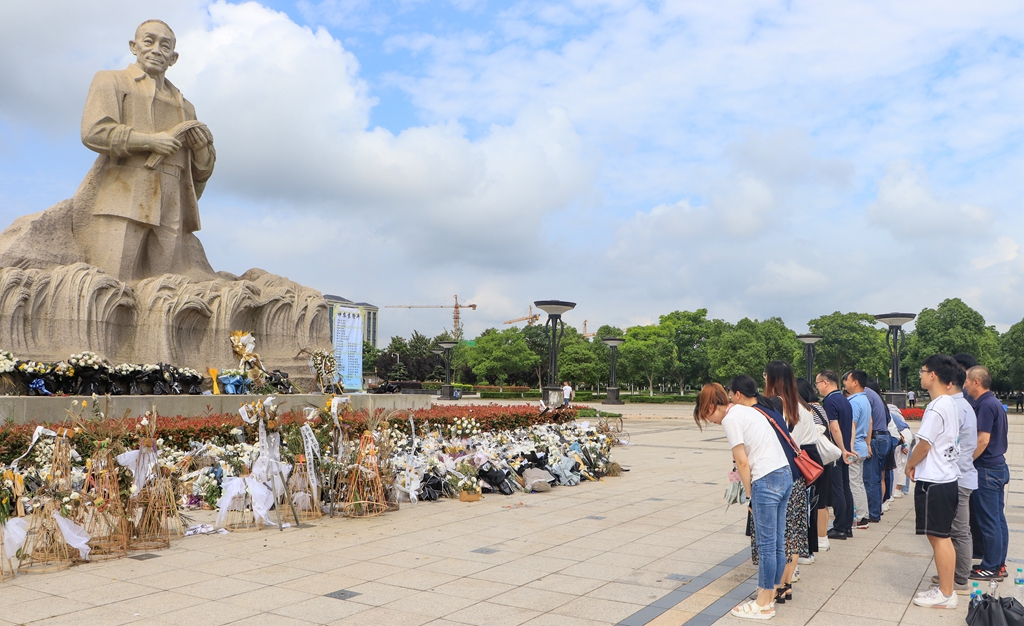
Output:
[0, 393, 431, 424]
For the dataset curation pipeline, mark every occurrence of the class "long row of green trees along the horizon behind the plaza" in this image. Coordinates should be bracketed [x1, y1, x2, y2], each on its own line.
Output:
[364, 298, 1024, 393]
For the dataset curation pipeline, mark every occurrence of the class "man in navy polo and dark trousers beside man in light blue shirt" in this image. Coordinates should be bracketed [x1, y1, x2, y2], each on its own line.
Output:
[814, 370, 857, 541]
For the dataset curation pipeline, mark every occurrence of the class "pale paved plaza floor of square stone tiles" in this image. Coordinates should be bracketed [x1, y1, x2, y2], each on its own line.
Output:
[0, 406, 1024, 626]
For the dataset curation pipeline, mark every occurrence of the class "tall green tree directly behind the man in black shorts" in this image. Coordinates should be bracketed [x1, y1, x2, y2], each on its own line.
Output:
[906, 298, 1002, 387]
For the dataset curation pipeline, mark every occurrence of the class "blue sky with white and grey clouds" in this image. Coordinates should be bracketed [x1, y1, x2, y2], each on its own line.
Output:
[0, 0, 1024, 344]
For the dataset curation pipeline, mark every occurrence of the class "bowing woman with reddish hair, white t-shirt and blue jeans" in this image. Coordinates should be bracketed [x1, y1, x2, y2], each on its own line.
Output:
[693, 376, 793, 620]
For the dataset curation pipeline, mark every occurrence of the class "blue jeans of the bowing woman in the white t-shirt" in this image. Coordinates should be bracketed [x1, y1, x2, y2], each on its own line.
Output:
[751, 465, 793, 589]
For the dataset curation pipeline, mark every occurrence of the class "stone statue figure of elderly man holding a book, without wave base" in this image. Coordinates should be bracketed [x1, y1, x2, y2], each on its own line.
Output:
[73, 19, 216, 283]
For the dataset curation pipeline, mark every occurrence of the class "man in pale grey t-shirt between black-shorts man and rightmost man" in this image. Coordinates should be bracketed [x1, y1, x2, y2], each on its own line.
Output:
[932, 360, 978, 595]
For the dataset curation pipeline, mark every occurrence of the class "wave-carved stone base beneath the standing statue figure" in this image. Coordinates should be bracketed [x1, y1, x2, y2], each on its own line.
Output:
[0, 263, 331, 377]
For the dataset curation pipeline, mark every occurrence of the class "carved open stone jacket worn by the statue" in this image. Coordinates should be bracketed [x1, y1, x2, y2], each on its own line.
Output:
[75, 64, 216, 233]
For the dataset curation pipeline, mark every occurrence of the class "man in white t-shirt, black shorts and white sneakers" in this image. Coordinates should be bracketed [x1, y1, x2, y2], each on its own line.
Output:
[906, 354, 961, 609]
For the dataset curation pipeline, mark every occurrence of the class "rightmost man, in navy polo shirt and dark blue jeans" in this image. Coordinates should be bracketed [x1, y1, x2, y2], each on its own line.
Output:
[965, 366, 1010, 580]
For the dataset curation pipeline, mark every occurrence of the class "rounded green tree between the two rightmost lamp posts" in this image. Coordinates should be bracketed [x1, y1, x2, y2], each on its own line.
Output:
[800, 310, 889, 385]
